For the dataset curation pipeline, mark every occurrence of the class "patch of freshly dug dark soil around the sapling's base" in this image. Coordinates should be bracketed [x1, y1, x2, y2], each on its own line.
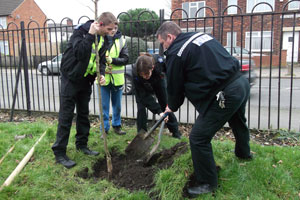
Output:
[77, 142, 188, 191]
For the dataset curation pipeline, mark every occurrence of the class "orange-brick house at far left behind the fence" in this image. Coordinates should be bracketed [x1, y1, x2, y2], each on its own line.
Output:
[0, 0, 47, 55]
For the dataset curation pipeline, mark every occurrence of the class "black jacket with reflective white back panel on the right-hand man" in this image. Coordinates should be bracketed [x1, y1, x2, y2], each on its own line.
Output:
[165, 33, 240, 114]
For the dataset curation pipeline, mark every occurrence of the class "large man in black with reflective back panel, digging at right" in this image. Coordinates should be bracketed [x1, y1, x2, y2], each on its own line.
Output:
[157, 22, 252, 197]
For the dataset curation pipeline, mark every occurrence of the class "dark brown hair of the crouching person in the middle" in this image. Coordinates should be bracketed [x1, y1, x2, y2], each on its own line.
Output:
[135, 53, 155, 76]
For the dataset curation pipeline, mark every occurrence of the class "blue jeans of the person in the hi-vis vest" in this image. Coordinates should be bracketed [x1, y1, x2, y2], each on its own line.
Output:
[98, 84, 123, 132]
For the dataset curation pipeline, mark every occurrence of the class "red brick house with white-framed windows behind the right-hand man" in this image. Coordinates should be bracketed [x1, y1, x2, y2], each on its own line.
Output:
[171, 0, 300, 66]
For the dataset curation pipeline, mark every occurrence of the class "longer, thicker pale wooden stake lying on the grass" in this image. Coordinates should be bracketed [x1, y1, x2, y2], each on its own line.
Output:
[0, 131, 47, 191]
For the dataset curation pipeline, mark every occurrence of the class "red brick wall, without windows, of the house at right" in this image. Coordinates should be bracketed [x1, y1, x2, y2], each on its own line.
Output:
[172, 0, 300, 64]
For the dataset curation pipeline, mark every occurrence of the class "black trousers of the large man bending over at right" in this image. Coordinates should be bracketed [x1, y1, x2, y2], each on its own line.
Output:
[189, 76, 250, 187]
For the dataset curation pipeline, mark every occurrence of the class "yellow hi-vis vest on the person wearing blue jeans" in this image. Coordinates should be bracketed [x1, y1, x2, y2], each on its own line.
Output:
[105, 37, 125, 86]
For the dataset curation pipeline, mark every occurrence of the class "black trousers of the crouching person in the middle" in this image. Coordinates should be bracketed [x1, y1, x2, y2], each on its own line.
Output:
[137, 79, 178, 133]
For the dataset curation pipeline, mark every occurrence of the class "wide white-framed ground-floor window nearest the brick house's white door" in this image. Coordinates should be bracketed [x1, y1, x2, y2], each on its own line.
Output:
[246, 31, 272, 51]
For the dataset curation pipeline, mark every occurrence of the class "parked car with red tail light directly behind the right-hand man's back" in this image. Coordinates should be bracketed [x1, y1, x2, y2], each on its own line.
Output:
[224, 46, 257, 86]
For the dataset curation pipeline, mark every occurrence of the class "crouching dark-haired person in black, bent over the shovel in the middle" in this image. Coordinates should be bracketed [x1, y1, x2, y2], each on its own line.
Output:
[133, 54, 181, 139]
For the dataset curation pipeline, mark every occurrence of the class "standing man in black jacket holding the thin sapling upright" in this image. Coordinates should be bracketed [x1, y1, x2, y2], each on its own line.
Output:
[52, 12, 117, 168]
